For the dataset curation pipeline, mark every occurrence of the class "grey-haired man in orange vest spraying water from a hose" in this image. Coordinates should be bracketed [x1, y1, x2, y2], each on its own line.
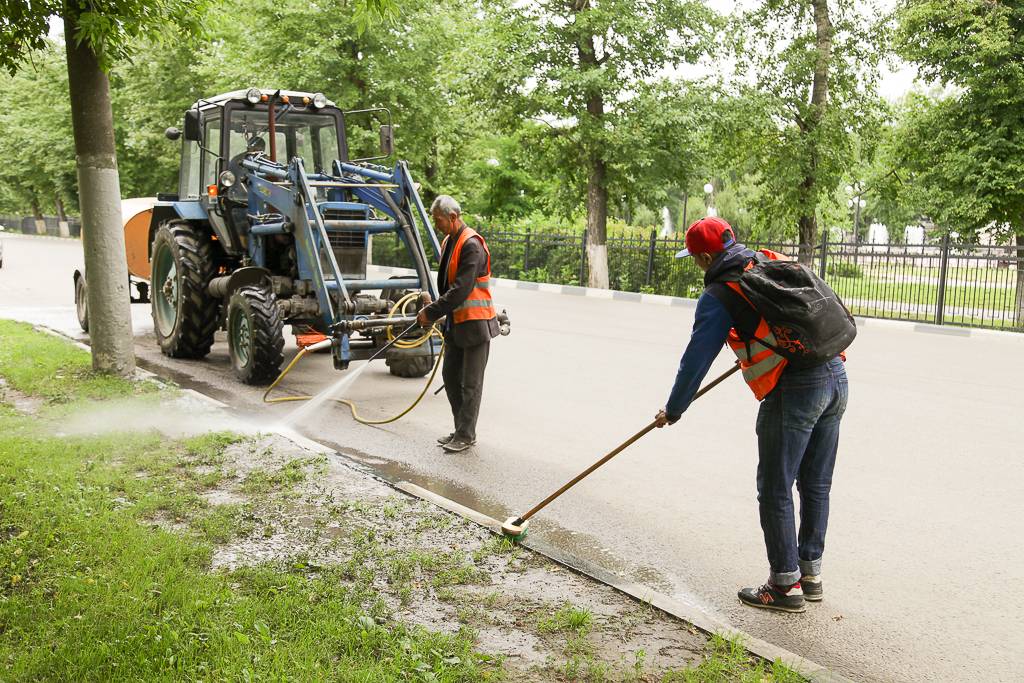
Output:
[417, 195, 499, 453]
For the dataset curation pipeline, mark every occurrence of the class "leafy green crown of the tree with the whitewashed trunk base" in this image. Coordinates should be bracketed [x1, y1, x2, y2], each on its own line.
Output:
[479, 0, 717, 260]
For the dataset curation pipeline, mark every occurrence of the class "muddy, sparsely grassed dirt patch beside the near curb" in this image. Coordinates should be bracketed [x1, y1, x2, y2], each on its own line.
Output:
[185, 435, 707, 681]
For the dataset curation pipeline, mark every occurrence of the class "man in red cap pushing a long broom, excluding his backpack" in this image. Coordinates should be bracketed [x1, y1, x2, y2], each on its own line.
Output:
[655, 217, 848, 612]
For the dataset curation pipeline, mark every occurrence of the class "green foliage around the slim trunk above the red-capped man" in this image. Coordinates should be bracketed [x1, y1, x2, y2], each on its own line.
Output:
[727, 0, 886, 242]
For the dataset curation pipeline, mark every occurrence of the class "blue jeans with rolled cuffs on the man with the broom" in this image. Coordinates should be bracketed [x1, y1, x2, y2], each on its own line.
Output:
[757, 357, 848, 586]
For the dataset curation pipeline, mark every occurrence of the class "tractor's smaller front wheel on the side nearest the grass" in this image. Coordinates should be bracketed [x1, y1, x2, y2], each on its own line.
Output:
[227, 287, 285, 384]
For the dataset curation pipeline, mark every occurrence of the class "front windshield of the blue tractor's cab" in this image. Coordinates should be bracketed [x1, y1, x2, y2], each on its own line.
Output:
[228, 109, 338, 173]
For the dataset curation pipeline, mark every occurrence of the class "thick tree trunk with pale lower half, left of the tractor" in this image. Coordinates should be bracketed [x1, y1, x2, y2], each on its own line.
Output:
[63, 3, 135, 376]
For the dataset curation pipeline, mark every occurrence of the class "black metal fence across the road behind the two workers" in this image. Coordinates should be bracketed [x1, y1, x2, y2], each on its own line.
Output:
[373, 228, 1024, 332]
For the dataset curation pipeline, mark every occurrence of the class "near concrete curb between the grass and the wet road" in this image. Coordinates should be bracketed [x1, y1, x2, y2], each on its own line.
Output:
[34, 326, 853, 683]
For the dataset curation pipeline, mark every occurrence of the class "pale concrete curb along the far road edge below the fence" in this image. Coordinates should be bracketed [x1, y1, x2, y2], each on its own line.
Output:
[373, 265, 1024, 340]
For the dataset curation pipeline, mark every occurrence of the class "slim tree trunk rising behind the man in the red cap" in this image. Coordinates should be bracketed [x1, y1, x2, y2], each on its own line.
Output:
[798, 0, 835, 263]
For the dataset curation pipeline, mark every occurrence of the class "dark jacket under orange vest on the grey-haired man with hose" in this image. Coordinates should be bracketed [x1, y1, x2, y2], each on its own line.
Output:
[426, 225, 498, 348]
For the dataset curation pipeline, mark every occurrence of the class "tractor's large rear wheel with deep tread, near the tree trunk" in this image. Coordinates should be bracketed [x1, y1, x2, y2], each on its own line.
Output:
[150, 221, 220, 358]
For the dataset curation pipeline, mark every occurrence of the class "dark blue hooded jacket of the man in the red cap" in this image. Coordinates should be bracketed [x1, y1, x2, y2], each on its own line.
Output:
[665, 243, 754, 421]
